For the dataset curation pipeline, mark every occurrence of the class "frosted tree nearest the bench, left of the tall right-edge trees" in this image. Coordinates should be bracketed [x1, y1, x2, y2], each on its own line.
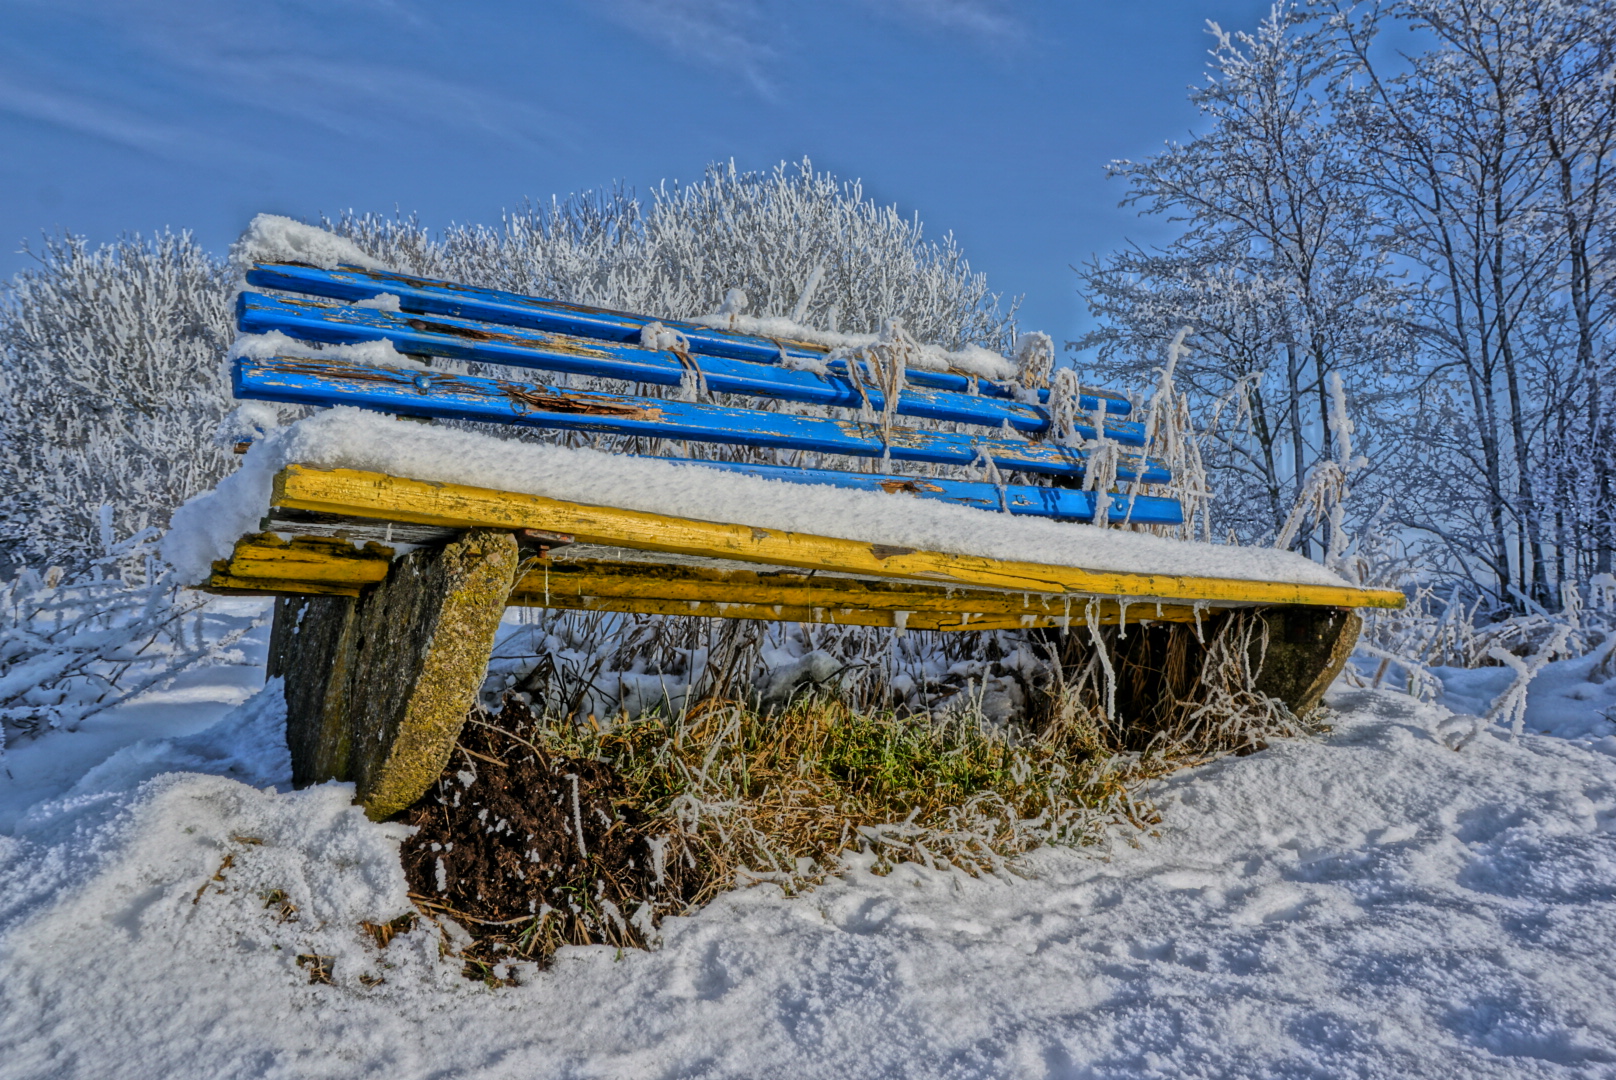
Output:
[1075, 6, 1408, 550]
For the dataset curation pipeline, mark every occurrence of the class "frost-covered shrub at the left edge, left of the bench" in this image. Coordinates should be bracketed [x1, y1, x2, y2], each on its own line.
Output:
[0, 233, 233, 571]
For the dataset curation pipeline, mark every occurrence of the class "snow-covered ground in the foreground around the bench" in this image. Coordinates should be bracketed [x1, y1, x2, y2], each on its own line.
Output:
[0, 614, 1616, 1080]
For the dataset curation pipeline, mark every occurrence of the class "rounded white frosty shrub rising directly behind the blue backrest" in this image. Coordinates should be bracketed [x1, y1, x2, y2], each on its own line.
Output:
[325, 160, 1015, 352]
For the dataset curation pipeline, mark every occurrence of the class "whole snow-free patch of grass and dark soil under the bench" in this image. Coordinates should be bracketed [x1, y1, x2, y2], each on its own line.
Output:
[433, 613, 1324, 977]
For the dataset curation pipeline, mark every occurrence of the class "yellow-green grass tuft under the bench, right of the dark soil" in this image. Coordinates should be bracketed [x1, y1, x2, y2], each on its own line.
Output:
[548, 697, 1169, 902]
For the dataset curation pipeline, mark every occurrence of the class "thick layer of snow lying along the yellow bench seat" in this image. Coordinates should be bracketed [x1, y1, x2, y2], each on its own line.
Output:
[163, 407, 1346, 585]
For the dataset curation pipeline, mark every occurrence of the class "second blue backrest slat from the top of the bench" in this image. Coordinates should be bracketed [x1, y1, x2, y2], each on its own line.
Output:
[236, 293, 1144, 446]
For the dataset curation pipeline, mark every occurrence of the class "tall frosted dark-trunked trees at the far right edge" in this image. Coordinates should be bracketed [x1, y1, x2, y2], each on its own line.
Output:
[1319, 0, 1616, 605]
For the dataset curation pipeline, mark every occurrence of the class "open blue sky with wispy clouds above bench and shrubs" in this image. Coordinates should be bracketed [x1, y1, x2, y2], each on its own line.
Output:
[0, 0, 1269, 340]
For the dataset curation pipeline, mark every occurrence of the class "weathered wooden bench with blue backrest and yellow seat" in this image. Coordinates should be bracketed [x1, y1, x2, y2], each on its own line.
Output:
[207, 264, 1403, 818]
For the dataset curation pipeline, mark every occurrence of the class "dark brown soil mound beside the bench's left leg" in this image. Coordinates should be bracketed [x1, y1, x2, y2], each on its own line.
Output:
[398, 702, 701, 978]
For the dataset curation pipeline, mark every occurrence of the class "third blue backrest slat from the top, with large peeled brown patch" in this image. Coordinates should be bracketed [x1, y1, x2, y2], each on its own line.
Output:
[233, 357, 1170, 483]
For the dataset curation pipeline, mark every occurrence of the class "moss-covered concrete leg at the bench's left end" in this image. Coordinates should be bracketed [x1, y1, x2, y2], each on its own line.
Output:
[270, 529, 519, 821]
